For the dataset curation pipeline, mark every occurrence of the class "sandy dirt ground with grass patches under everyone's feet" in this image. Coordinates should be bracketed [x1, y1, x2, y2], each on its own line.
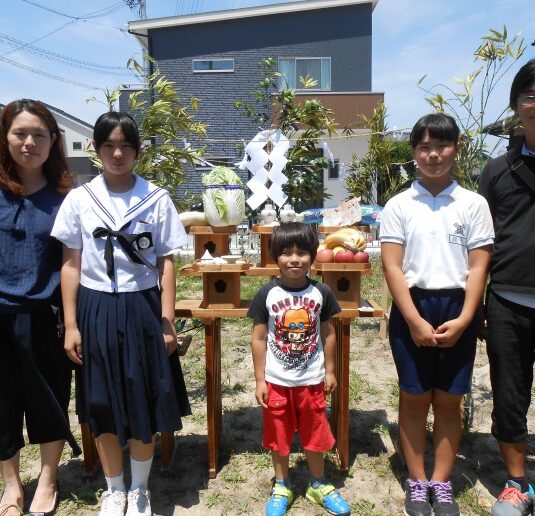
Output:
[11, 319, 535, 516]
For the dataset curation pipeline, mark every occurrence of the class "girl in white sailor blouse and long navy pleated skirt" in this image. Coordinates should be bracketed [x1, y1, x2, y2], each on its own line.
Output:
[52, 112, 190, 515]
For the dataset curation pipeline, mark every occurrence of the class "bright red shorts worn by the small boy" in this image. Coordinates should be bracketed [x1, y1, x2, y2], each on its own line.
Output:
[262, 382, 335, 456]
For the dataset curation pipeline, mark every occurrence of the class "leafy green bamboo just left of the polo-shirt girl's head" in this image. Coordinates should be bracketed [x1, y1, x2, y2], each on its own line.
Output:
[345, 103, 415, 205]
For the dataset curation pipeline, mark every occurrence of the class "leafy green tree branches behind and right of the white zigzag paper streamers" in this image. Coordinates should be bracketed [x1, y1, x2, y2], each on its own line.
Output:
[234, 58, 336, 211]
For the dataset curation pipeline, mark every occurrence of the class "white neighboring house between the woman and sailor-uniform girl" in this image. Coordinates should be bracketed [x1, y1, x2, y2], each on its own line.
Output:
[0, 103, 98, 184]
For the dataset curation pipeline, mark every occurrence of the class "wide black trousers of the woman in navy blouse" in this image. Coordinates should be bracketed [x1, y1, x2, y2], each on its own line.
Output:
[0, 306, 80, 460]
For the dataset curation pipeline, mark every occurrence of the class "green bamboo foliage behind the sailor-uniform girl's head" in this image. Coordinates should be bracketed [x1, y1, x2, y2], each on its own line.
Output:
[88, 58, 206, 208]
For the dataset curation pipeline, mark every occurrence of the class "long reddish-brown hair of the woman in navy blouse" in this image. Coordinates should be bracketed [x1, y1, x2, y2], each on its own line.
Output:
[0, 99, 73, 195]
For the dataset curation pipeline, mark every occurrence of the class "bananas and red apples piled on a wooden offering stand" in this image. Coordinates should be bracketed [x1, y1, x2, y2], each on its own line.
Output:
[316, 228, 370, 263]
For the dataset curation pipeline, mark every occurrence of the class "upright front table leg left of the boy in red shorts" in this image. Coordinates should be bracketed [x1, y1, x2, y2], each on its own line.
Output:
[204, 318, 222, 478]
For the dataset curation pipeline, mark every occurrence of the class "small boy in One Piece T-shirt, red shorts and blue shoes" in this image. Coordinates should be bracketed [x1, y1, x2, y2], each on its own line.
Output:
[247, 222, 351, 516]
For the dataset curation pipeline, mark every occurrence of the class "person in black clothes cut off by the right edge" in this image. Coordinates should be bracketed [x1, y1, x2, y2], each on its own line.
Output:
[479, 59, 535, 516]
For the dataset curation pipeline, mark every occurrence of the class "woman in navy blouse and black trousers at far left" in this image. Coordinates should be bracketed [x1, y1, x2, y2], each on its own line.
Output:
[0, 99, 80, 516]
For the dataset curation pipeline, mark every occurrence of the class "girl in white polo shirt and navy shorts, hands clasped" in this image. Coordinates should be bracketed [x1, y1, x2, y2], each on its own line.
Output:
[380, 113, 494, 516]
